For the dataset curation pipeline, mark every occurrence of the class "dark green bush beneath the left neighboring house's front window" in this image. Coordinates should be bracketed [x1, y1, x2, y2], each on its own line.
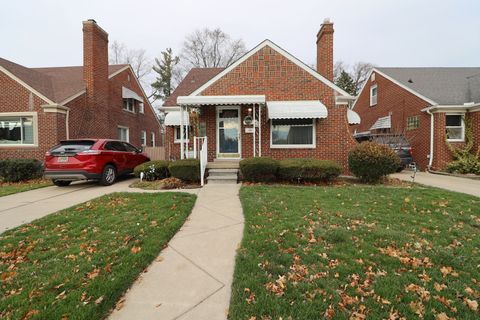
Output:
[0, 159, 43, 182]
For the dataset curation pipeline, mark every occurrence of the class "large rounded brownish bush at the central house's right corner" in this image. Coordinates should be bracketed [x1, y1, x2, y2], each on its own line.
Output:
[348, 142, 401, 182]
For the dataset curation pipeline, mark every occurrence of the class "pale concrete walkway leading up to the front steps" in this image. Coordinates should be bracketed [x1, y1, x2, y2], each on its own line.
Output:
[110, 184, 243, 320]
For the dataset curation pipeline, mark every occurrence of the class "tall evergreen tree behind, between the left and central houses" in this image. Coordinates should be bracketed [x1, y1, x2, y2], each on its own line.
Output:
[152, 48, 180, 100]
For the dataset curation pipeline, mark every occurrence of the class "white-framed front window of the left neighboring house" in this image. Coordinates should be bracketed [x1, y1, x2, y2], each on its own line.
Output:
[0, 115, 34, 145]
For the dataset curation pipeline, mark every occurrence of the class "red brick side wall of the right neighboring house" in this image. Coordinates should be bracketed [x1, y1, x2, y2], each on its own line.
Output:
[352, 73, 436, 170]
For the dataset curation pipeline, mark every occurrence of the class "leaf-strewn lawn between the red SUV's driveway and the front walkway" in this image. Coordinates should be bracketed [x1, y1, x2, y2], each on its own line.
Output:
[0, 193, 195, 319]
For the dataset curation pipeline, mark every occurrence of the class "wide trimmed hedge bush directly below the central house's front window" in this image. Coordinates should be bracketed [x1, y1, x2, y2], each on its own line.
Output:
[278, 159, 342, 182]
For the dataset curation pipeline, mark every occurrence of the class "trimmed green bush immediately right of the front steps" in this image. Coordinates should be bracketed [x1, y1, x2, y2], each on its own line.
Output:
[240, 157, 278, 182]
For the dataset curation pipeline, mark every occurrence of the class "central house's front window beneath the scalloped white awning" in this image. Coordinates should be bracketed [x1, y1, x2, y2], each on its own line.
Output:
[271, 119, 315, 148]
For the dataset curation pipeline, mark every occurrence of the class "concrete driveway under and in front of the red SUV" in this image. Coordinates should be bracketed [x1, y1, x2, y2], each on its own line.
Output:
[0, 177, 198, 233]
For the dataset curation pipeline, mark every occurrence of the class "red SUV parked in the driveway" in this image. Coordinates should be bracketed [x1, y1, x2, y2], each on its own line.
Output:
[45, 139, 150, 187]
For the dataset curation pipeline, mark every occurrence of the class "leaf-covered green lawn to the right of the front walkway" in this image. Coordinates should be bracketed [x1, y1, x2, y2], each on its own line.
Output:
[230, 185, 480, 320]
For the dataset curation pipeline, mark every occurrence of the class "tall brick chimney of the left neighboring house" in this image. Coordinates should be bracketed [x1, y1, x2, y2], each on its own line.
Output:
[83, 19, 108, 106]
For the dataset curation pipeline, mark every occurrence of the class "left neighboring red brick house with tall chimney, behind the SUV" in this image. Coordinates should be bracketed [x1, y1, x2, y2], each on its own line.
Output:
[0, 20, 161, 160]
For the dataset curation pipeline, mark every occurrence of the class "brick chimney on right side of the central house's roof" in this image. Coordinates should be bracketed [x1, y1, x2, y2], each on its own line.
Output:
[317, 18, 333, 81]
